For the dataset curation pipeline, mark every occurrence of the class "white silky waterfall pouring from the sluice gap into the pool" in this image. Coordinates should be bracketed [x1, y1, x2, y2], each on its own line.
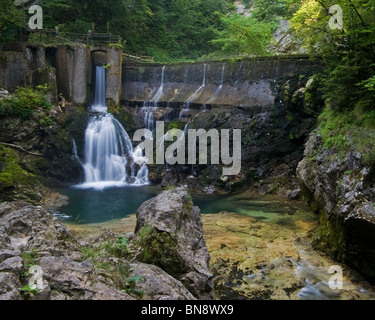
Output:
[78, 67, 149, 189]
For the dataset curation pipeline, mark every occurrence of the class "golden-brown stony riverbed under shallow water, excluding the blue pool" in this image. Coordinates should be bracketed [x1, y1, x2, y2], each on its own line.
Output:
[66, 195, 375, 300]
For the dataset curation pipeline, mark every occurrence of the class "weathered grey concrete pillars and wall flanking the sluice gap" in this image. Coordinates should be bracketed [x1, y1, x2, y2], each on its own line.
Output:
[0, 44, 122, 105]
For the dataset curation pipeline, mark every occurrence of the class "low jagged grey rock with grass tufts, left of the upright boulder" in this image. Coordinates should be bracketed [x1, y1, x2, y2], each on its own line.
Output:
[0, 202, 201, 300]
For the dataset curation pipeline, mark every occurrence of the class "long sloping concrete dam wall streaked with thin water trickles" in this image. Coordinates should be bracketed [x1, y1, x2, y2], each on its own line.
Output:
[121, 56, 319, 109]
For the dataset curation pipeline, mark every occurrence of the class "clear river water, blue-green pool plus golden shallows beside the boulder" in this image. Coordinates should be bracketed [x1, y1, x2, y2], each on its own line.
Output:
[55, 186, 375, 300]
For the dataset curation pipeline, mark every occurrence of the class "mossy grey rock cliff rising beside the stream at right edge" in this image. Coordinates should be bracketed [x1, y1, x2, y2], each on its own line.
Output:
[297, 132, 375, 280]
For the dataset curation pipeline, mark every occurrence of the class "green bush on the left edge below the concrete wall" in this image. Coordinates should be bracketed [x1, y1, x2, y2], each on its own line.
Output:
[0, 85, 51, 119]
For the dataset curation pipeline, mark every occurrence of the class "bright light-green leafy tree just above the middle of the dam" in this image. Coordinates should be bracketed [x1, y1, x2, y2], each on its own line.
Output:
[211, 14, 272, 55]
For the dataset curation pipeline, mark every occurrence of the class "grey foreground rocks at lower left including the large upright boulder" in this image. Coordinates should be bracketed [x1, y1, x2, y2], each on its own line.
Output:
[0, 190, 214, 300]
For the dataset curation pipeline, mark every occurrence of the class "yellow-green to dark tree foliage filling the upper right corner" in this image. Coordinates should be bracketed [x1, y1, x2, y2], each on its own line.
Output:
[290, 0, 375, 111]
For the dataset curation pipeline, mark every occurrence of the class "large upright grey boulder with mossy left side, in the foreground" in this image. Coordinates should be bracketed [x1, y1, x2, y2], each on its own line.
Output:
[135, 187, 214, 299]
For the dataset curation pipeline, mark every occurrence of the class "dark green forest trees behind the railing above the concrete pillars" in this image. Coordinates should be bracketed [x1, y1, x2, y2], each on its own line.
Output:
[0, 0, 238, 62]
